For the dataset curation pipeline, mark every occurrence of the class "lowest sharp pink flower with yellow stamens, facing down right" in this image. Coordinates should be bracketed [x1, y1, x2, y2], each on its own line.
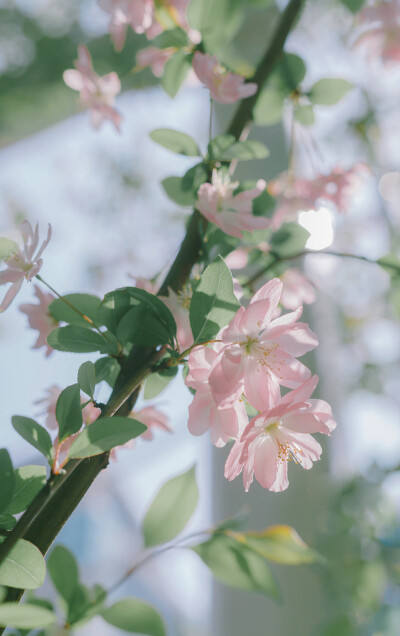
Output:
[225, 375, 336, 492]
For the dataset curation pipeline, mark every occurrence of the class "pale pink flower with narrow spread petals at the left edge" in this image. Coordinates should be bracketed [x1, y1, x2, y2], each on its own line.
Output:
[0, 221, 51, 313]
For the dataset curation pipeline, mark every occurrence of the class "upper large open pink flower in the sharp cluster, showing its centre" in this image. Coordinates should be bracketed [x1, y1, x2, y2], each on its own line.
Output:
[209, 278, 318, 410]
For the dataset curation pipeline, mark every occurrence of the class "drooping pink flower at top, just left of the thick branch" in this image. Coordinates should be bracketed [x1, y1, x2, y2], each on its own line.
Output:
[193, 51, 257, 104]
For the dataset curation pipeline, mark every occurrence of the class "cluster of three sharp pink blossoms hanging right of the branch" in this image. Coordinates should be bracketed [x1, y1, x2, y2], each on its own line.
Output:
[186, 278, 336, 492]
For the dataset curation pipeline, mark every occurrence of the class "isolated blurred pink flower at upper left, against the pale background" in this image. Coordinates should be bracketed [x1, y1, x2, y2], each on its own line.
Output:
[63, 44, 122, 131]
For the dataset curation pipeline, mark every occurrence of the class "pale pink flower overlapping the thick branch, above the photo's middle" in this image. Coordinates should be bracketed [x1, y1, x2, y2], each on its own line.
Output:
[196, 170, 271, 238]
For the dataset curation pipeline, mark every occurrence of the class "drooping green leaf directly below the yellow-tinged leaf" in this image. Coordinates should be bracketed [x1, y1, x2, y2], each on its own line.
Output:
[192, 534, 280, 600]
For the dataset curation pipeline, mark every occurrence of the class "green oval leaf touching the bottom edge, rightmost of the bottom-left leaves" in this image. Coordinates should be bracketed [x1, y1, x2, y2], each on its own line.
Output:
[101, 598, 166, 636]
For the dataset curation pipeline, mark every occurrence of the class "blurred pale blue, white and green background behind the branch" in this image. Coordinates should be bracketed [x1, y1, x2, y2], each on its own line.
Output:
[0, 0, 400, 636]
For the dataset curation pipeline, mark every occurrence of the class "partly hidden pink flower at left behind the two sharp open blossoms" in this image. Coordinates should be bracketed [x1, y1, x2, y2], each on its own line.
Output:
[185, 347, 248, 447]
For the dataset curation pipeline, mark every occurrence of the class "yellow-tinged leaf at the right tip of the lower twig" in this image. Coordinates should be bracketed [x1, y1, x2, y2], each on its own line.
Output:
[231, 525, 321, 565]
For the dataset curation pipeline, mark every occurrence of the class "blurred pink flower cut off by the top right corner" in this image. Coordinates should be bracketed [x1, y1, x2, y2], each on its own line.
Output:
[353, 0, 400, 64]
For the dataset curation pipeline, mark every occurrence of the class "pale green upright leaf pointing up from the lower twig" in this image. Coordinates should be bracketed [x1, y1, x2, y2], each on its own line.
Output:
[143, 466, 199, 548]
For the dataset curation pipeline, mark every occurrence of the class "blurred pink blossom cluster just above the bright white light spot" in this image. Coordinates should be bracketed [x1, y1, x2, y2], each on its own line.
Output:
[268, 162, 369, 229]
